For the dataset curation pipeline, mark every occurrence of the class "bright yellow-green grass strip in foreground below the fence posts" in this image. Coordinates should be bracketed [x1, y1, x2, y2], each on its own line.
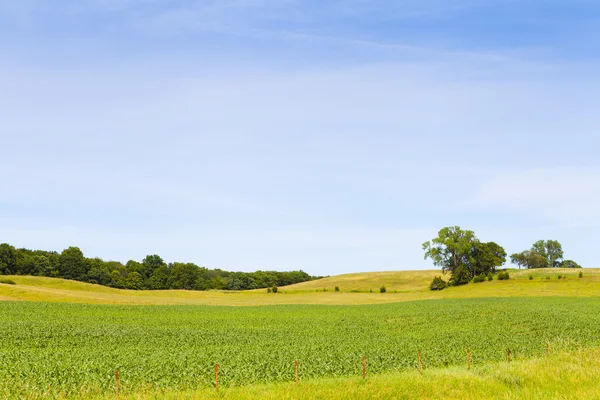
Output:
[42, 349, 600, 400]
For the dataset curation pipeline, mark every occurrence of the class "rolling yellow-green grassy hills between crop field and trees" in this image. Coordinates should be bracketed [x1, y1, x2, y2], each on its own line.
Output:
[0, 269, 600, 306]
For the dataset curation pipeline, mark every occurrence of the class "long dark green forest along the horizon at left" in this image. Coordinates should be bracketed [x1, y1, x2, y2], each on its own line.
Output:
[0, 243, 320, 290]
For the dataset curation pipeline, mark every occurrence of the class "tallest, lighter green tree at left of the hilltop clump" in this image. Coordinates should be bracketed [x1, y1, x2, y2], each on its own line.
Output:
[423, 226, 477, 281]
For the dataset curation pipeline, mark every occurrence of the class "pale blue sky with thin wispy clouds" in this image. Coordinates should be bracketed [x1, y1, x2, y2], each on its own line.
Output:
[0, 0, 600, 275]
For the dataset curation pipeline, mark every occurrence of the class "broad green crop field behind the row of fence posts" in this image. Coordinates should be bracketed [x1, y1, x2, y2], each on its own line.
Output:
[0, 298, 600, 398]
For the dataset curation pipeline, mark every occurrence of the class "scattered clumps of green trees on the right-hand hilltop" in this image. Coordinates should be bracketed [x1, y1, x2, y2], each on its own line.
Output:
[423, 226, 581, 290]
